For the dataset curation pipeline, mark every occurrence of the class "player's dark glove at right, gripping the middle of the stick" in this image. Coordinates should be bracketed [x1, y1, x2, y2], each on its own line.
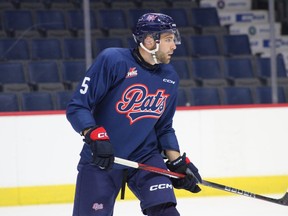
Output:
[166, 153, 202, 193]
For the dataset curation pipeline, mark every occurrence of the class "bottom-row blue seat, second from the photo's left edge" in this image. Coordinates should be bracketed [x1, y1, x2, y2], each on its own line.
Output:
[21, 92, 55, 111]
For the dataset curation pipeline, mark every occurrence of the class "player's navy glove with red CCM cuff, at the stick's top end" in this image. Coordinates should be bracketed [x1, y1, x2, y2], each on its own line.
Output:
[84, 126, 114, 170]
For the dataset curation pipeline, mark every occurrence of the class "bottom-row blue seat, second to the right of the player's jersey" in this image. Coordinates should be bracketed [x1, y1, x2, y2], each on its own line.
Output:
[190, 88, 221, 106]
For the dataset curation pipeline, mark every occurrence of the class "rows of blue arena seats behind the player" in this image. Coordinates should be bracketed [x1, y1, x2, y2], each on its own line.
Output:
[0, 0, 288, 112]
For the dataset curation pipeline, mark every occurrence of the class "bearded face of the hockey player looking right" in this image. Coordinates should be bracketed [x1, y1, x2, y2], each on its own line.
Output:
[156, 33, 176, 64]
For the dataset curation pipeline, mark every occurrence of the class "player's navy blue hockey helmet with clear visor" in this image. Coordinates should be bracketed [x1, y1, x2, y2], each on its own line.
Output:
[133, 13, 181, 44]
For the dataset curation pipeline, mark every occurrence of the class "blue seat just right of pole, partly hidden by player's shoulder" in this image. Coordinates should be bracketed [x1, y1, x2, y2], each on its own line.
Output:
[93, 37, 124, 57]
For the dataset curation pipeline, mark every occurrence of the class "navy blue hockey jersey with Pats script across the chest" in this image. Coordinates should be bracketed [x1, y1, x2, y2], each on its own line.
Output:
[67, 48, 179, 164]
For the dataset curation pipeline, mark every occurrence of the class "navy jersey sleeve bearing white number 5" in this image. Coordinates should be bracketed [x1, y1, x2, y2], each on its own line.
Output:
[66, 49, 115, 133]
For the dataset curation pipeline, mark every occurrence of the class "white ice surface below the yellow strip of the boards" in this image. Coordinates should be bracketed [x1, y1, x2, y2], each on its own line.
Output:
[0, 195, 288, 216]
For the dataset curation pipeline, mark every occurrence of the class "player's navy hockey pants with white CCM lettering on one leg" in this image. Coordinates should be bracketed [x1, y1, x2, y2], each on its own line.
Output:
[73, 154, 179, 216]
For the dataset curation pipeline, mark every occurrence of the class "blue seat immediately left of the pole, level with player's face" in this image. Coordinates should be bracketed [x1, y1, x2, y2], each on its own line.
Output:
[63, 38, 85, 59]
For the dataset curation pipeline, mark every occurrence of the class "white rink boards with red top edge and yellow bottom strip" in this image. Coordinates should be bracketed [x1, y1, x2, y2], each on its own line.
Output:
[0, 105, 288, 206]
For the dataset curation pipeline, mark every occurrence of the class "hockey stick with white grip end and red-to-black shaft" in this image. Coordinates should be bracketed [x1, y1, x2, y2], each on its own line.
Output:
[114, 157, 288, 206]
